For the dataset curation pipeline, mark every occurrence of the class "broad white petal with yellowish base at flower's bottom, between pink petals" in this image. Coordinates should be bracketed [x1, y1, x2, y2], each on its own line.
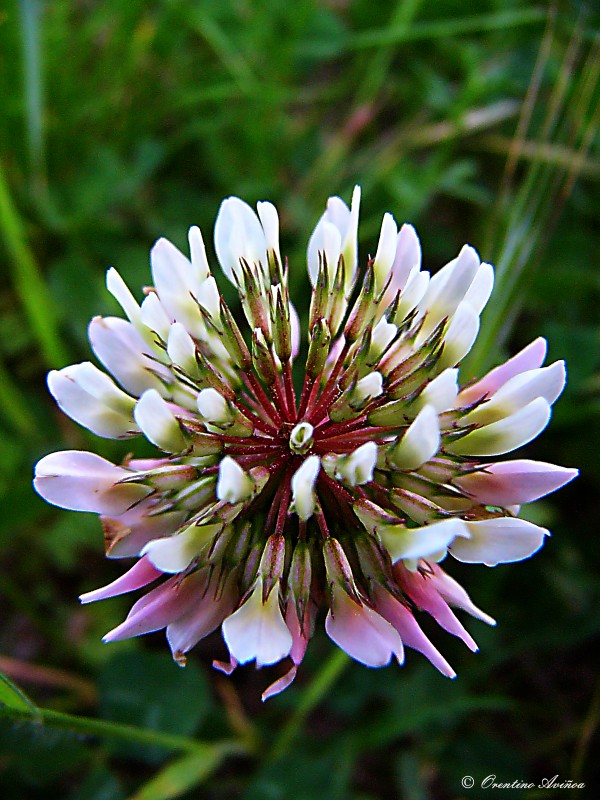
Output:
[222, 581, 292, 666]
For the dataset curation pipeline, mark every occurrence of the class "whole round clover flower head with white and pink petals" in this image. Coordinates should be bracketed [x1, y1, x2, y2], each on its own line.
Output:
[35, 187, 576, 697]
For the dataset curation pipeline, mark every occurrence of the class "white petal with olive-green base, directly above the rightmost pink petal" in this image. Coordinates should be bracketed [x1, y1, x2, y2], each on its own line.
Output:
[446, 397, 550, 456]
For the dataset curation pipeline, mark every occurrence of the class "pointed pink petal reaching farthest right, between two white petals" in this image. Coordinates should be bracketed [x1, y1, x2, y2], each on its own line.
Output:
[454, 459, 579, 506]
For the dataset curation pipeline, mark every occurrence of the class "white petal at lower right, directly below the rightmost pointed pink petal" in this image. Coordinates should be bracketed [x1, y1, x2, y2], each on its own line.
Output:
[449, 517, 549, 567]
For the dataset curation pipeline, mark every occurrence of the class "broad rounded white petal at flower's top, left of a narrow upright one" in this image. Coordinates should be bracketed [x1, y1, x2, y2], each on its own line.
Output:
[215, 197, 267, 283]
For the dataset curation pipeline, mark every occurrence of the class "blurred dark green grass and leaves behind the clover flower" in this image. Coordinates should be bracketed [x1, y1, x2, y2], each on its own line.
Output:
[0, 0, 600, 800]
